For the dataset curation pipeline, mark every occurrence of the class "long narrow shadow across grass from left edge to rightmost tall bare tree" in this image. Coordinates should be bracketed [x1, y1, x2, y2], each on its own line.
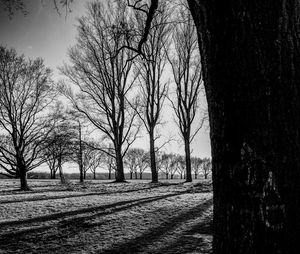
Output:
[0, 191, 186, 228]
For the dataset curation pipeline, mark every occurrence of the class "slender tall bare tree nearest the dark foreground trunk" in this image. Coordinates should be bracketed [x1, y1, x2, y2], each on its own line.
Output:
[168, 4, 205, 182]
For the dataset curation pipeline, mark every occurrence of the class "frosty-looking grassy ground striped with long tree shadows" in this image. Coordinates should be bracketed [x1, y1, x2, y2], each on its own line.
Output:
[0, 180, 212, 253]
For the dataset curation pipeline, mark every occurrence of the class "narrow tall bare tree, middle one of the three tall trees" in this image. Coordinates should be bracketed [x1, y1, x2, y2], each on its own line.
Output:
[135, 0, 170, 182]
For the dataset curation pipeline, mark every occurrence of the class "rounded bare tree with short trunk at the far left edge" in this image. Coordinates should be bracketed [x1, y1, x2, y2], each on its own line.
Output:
[0, 47, 55, 190]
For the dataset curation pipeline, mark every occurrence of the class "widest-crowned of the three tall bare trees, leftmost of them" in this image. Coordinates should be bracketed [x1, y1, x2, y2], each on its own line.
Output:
[61, 1, 139, 182]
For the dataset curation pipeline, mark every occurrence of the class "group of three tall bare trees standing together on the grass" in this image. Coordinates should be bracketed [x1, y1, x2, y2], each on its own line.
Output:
[60, 1, 205, 185]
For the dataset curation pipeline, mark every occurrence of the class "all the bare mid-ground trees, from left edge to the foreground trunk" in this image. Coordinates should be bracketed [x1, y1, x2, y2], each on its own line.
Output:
[0, 1, 203, 190]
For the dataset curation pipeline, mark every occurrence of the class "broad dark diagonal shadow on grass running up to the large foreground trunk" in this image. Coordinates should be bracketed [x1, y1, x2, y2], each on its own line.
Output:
[99, 199, 213, 254]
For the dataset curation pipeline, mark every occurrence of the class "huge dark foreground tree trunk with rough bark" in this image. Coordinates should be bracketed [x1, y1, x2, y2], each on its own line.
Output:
[188, 0, 300, 254]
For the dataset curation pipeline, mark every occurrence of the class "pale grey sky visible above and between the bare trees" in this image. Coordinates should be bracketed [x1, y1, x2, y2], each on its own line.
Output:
[0, 0, 211, 166]
